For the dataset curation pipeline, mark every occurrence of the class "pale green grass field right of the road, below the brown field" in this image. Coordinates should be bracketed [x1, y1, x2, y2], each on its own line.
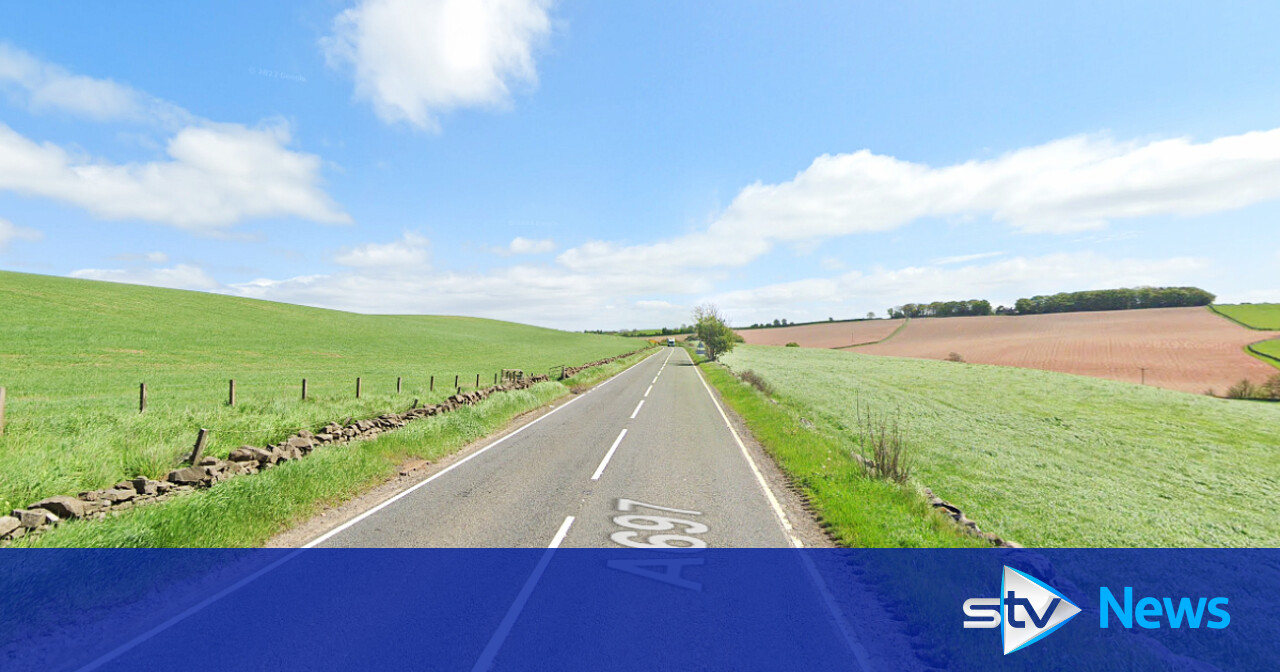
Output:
[724, 346, 1280, 547]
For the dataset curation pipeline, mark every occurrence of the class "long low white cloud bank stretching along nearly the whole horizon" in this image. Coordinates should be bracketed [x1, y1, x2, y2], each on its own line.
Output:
[62, 243, 1208, 330]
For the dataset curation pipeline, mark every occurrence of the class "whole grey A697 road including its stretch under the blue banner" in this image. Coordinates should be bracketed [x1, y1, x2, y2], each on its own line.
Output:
[32, 348, 890, 672]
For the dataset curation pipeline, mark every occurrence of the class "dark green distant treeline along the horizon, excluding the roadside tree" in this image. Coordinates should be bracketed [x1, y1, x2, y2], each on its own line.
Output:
[589, 287, 1217, 337]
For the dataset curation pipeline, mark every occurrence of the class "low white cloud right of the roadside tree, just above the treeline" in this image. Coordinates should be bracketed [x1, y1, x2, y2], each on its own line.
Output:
[708, 252, 1210, 324]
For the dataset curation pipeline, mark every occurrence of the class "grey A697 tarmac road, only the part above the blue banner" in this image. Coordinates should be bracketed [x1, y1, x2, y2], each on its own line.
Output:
[307, 348, 800, 548]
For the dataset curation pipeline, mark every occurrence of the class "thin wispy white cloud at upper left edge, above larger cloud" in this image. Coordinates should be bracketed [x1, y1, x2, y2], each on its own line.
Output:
[0, 44, 193, 125]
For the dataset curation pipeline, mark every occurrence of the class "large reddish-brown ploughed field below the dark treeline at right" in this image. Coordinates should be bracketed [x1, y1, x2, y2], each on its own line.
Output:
[778, 307, 1280, 394]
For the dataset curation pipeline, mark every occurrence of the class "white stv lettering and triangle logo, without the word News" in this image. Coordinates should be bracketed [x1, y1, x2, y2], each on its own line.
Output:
[964, 564, 1080, 655]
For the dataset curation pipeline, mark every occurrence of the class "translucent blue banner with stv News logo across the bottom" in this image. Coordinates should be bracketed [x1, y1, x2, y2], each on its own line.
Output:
[0, 549, 1280, 671]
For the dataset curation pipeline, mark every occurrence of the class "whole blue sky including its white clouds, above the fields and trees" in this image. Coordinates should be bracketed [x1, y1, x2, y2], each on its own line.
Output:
[0, 0, 1280, 329]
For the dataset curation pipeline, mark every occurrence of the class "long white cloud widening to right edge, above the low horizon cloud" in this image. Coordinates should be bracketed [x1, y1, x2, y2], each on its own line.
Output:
[559, 129, 1280, 271]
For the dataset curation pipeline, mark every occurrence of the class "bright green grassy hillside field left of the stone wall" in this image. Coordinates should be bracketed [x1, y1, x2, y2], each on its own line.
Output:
[0, 273, 636, 511]
